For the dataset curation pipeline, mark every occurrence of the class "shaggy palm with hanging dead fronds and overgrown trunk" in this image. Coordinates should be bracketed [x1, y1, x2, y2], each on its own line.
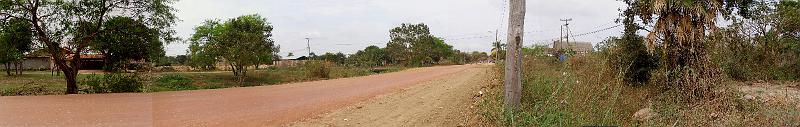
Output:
[624, 0, 750, 101]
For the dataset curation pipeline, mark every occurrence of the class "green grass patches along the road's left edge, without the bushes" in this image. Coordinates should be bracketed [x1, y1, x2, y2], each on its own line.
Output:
[0, 67, 405, 96]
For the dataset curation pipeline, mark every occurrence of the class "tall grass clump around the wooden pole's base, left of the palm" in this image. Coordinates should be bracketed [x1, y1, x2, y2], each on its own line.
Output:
[482, 52, 647, 126]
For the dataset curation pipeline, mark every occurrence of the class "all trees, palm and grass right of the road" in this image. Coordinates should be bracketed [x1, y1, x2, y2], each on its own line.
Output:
[479, 0, 800, 126]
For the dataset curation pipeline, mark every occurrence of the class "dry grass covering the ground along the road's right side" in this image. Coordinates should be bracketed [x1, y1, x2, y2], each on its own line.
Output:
[480, 54, 800, 126]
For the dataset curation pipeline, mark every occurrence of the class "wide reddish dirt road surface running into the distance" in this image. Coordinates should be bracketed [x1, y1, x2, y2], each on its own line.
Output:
[0, 65, 476, 127]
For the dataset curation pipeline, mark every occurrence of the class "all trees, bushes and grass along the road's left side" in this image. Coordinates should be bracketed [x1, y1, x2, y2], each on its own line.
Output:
[0, 0, 488, 96]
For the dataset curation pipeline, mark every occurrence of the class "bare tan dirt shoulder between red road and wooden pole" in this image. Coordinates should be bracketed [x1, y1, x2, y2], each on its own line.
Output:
[287, 66, 491, 127]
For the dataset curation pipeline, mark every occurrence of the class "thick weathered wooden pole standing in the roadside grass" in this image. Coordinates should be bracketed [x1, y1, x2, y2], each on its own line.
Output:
[505, 0, 525, 110]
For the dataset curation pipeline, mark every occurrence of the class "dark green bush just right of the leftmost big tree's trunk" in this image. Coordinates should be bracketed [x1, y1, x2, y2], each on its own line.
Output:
[80, 73, 144, 93]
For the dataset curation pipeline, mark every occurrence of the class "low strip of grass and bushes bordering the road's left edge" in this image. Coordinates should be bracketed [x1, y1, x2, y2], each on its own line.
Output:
[0, 66, 406, 96]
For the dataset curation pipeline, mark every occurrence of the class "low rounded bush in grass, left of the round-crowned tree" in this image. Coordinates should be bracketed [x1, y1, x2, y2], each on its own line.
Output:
[154, 74, 197, 91]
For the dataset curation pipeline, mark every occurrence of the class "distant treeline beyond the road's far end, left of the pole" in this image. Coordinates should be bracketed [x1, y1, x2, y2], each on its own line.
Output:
[310, 23, 489, 67]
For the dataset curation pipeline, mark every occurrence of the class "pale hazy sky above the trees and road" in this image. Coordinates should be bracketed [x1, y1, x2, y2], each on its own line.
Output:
[167, 0, 624, 56]
